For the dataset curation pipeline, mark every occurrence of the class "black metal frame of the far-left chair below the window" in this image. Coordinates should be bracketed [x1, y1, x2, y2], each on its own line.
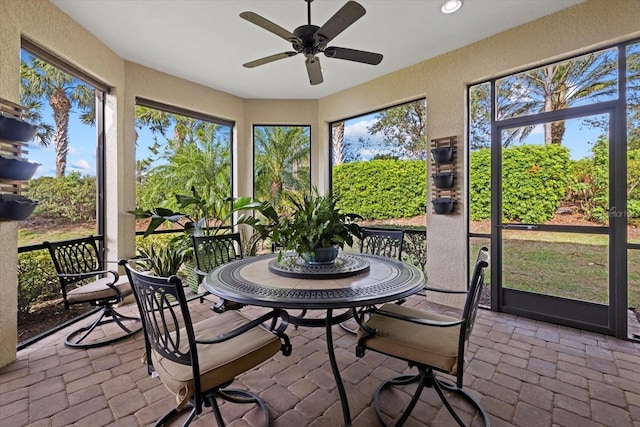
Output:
[44, 236, 142, 348]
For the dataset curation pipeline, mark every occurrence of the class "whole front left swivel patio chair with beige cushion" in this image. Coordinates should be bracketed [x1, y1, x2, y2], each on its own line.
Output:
[120, 260, 291, 426]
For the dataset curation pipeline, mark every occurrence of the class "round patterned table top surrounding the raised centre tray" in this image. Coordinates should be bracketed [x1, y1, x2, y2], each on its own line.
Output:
[203, 253, 424, 309]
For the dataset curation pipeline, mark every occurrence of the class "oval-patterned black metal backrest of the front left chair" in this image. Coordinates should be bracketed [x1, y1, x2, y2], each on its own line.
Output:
[120, 260, 199, 372]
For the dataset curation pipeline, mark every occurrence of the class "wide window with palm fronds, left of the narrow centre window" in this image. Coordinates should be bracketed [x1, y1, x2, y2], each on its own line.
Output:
[136, 99, 233, 225]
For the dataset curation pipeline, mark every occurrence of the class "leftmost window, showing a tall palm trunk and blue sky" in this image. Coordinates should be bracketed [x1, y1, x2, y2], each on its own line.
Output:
[18, 40, 108, 246]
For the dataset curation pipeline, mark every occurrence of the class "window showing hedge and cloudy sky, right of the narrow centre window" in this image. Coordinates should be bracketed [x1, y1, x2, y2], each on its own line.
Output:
[331, 99, 427, 227]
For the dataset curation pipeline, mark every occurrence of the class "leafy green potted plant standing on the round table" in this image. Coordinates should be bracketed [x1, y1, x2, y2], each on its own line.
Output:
[272, 188, 362, 264]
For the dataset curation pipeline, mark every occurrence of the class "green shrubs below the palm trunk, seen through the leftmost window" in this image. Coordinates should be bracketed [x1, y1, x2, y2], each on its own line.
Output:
[28, 172, 96, 222]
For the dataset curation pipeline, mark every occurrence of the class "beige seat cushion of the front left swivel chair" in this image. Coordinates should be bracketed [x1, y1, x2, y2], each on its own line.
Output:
[151, 311, 281, 408]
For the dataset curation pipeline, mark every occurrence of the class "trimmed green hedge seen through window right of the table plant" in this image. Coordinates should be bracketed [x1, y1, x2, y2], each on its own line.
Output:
[333, 159, 427, 219]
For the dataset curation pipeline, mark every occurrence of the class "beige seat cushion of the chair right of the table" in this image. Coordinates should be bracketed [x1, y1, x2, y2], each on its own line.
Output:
[358, 304, 460, 375]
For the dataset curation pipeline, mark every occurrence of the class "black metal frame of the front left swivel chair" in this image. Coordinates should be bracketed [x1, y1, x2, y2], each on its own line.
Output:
[119, 259, 292, 427]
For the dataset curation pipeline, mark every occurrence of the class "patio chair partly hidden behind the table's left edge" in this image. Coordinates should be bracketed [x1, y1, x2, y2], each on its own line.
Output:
[192, 233, 243, 313]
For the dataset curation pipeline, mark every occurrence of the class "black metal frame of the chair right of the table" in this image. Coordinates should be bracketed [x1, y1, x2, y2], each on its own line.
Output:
[356, 247, 491, 426]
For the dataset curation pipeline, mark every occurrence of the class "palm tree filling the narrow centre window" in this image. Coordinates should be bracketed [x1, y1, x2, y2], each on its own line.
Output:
[254, 126, 311, 210]
